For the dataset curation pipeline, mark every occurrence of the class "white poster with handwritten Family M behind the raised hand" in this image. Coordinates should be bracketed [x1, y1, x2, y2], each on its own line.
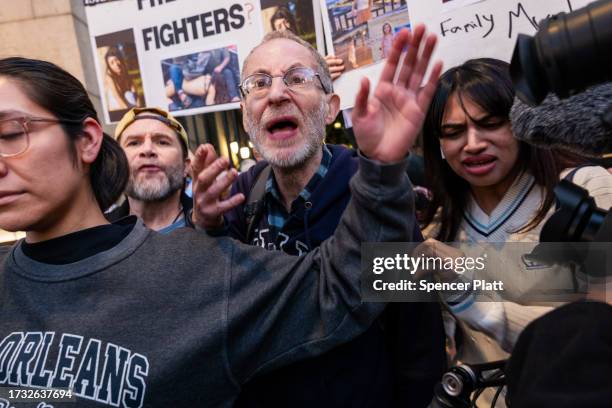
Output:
[320, 0, 592, 109]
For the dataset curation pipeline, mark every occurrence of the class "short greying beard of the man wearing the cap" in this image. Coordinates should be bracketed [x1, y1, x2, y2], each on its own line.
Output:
[126, 163, 185, 202]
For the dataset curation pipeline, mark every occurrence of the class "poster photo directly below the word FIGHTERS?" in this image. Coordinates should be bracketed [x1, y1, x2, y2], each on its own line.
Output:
[161, 45, 240, 111]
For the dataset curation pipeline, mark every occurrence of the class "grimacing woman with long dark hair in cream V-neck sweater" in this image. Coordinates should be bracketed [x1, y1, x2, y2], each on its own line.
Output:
[423, 58, 612, 404]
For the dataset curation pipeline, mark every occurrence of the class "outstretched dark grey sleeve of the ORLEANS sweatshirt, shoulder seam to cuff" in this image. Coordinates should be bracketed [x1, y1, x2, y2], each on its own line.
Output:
[227, 158, 415, 383]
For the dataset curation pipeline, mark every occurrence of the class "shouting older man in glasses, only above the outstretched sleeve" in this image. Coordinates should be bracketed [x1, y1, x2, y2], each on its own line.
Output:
[194, 31, 376, 250]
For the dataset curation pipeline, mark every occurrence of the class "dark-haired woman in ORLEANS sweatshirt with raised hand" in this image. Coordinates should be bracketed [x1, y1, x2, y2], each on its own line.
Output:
[0, 25, 440, 408]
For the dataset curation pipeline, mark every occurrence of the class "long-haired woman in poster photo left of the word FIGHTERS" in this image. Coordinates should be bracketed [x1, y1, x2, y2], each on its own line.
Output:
[104, 46, 141, 111]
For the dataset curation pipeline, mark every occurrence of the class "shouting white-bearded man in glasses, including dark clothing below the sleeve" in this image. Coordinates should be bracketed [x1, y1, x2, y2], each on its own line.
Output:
[194, 27, 445, 408]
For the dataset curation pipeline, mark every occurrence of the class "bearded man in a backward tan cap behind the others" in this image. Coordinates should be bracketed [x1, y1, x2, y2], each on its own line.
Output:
[106, 108, 193, 233]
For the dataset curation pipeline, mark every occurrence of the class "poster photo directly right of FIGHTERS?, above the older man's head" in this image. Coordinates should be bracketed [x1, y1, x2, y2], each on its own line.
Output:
[261, 0, 317, 48]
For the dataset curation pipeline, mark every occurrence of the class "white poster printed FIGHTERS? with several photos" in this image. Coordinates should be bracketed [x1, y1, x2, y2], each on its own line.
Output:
[84, 0, 323, 123]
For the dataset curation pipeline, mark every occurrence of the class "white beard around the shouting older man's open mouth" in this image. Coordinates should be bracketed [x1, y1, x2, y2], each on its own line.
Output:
[246, 98, 327, 169]
